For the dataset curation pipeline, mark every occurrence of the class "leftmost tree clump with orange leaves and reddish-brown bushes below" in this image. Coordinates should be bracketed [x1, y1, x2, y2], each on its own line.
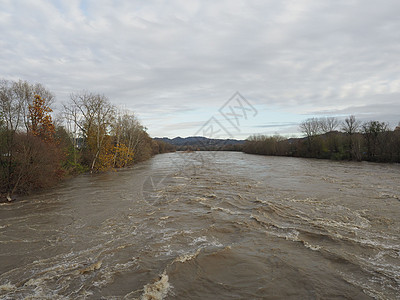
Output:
[0, 80, 63, 201]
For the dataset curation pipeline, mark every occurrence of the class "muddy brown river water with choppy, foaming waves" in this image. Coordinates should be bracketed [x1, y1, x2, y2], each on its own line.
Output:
[0, 152, 400, 299]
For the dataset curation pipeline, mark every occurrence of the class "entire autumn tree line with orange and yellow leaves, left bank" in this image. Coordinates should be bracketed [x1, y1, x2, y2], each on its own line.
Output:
[0, 80, 174, 200]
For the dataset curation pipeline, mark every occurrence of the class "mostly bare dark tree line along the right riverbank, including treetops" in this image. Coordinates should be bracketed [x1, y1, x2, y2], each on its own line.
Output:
[243, 115, 400, 163]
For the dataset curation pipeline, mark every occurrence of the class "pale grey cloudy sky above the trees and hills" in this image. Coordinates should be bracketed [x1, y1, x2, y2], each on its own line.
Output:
[0, 0, 400, 138]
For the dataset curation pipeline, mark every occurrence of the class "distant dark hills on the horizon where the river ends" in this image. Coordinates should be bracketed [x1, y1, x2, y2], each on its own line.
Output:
[154, 136, 245, 151]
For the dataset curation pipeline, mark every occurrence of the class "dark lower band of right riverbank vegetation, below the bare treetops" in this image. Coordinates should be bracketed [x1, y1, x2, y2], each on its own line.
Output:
[242, 130, 400, 163]
